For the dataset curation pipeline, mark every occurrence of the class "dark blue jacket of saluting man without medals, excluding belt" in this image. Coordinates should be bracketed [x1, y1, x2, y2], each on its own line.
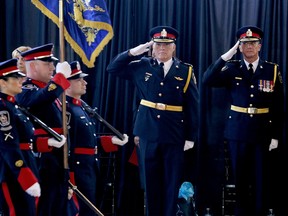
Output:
[107, 51, 198, 145]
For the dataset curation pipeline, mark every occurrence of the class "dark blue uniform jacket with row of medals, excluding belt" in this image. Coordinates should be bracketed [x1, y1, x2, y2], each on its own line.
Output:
[203, 58, 284, 142]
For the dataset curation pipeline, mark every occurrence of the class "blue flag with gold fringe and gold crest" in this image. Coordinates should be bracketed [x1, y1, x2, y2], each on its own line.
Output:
[31, 0, 114, 68]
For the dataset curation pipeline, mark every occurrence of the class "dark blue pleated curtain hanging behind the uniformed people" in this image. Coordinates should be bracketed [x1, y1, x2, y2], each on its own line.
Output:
[0, 0, 288, 215]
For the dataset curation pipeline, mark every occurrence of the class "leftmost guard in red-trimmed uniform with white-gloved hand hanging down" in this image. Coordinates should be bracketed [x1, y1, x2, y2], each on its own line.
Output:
[0, 59, 41, 216]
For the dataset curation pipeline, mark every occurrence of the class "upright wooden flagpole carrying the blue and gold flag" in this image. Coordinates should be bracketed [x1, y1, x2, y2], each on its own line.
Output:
[59, 0, 69, 169]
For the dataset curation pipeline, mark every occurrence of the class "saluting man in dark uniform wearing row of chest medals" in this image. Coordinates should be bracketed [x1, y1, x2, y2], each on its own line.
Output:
[203, 26, 284, 215]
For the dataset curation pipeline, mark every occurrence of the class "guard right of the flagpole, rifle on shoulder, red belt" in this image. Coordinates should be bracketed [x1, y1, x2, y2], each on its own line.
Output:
[66, 61, 128, 216]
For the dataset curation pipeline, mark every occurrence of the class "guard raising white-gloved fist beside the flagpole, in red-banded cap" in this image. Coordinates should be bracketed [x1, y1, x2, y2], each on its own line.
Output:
[16, 43, 71, 216]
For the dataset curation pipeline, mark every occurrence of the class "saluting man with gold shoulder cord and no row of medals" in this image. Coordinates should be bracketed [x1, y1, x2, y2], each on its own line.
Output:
[107, 26, 199, 216]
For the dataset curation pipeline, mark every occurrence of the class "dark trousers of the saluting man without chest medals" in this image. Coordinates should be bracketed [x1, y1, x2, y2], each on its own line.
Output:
[139, 137, 184, 216]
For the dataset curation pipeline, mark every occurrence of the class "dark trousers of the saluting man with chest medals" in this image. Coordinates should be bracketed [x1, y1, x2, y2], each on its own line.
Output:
[228, 140, 269, 216]
